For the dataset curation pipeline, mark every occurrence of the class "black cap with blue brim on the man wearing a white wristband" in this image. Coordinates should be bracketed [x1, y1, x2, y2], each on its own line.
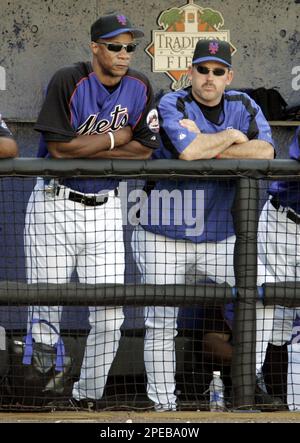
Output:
[91, 14, 144, 42]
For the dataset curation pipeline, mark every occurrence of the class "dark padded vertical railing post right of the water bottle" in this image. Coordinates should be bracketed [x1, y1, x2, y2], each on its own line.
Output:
[232, 177, 259, 408]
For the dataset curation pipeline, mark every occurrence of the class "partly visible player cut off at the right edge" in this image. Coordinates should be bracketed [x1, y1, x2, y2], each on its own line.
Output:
[258, 127, 300, 409]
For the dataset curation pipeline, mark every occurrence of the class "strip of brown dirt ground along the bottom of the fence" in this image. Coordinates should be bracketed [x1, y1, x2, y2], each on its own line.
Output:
[0, 411, 300, 424]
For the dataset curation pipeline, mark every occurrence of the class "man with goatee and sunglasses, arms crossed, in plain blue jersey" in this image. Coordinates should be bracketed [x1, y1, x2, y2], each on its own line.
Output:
[132, 40, 274, 411]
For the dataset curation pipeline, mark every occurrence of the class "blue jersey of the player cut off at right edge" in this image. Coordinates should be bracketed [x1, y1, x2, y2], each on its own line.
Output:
[269, 126, 300, 214]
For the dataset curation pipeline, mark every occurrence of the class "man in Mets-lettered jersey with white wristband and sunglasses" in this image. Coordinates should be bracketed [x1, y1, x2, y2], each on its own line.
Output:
[25, 14, 159, 410]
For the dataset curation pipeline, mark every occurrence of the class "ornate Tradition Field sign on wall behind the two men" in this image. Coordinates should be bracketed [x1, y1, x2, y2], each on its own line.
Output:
[145, 0, 236, 90]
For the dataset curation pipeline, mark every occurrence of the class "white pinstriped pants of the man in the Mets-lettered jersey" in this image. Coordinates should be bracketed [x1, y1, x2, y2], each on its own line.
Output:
[25, 180, 125, 400]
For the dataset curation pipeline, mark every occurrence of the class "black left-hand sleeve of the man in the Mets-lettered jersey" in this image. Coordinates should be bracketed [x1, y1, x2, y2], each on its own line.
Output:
[35, 68, 76, 141]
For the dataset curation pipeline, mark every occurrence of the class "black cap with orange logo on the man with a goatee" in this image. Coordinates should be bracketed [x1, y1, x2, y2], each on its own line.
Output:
[192, 40, 231, 68]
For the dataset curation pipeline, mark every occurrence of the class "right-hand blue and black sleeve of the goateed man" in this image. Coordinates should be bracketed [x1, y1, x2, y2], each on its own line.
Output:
[239, 94, 275, 146]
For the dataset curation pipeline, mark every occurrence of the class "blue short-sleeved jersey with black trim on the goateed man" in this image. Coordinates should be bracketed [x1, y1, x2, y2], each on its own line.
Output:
[141, 88, 273, 243]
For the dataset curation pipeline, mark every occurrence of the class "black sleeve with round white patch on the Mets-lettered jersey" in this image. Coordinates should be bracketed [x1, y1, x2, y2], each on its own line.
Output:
[133, 76, 160, 149]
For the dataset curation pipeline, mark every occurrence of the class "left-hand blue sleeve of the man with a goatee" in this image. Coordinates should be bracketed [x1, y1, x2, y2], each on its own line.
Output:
[158, 93, 197, 154]
